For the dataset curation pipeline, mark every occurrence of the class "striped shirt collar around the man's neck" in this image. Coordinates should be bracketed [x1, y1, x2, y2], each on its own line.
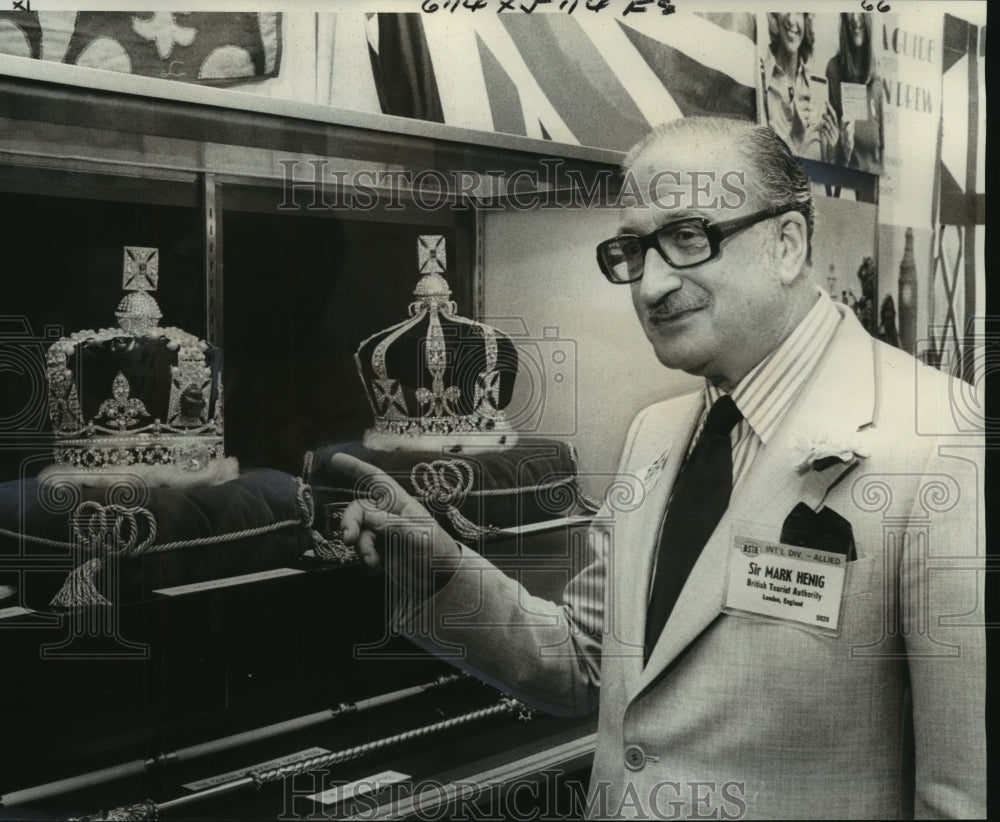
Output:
[705, 288, 841, 444]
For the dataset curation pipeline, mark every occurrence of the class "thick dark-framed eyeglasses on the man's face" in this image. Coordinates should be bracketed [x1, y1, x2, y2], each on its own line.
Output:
[597, 206, 794, 284]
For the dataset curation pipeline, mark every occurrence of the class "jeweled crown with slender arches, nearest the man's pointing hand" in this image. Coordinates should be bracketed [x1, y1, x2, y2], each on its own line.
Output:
[355, 236, 517, 451]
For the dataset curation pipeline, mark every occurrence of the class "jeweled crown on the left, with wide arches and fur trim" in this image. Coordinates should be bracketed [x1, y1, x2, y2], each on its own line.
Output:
[47, 246, 238, 484]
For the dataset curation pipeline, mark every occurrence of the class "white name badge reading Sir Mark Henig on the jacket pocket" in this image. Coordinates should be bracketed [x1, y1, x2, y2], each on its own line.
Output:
[722, 535, 847, 637]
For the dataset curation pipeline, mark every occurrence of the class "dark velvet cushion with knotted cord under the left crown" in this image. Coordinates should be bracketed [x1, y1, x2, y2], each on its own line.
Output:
[0, 469, 311, 608]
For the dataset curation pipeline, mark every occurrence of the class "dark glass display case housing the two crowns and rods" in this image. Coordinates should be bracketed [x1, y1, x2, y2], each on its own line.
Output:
[0, 57, 617, 818]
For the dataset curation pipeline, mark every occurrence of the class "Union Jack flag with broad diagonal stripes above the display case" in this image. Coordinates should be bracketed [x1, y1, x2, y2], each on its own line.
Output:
[362, 13, 756, 150]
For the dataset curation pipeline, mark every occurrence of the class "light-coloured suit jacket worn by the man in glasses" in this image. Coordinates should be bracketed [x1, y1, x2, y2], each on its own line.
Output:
[397, 311, 986, 819]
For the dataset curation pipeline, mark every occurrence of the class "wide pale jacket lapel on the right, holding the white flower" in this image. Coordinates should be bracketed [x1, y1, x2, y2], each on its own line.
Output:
[631, 311, 875, 698]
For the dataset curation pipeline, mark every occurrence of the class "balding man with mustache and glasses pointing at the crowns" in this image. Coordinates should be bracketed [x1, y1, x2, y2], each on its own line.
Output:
[338, 119, 986, 819]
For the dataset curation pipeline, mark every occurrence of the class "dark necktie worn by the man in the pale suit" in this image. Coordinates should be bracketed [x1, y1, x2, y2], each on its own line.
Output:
[645, 394, 743, 661]
